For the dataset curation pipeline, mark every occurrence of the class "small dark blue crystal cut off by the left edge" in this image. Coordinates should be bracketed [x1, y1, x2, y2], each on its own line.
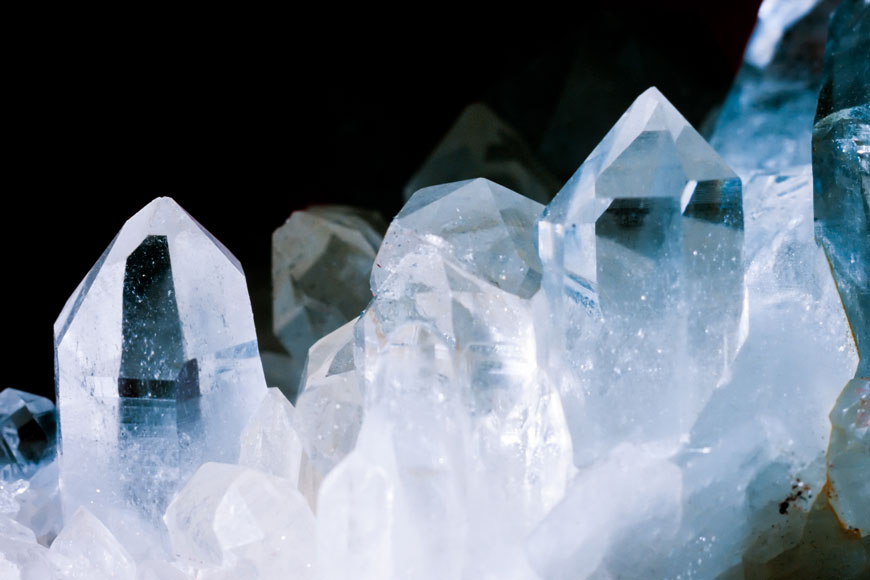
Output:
[0, 388, 57, 480]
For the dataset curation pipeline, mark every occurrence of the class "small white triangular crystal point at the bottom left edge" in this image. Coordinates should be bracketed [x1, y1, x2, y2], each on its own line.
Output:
[49, 507, 136, 580]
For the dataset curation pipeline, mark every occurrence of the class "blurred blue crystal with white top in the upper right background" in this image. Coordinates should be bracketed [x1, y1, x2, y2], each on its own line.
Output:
[710, 0, 837, 180]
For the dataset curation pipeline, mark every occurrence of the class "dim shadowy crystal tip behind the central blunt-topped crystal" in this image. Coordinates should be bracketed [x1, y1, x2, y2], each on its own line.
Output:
[405, 103, 559, 203]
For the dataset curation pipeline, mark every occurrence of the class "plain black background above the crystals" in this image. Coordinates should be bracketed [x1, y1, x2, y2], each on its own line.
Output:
[8, 0, 759, 404]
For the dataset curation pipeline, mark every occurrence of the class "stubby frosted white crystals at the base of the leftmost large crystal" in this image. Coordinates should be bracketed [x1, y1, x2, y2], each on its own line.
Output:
[164, 463, 316, 579]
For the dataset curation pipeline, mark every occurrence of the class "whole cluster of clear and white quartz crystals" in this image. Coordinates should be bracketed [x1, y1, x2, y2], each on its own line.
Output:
[0, 0, 870, 580]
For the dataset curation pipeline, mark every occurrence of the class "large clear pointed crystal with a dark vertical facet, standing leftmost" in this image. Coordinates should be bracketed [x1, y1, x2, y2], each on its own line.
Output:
[55, 198, 265, 555]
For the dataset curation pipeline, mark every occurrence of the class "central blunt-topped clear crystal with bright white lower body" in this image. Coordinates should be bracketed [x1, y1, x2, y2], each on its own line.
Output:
[344, 179, 571, 578]
